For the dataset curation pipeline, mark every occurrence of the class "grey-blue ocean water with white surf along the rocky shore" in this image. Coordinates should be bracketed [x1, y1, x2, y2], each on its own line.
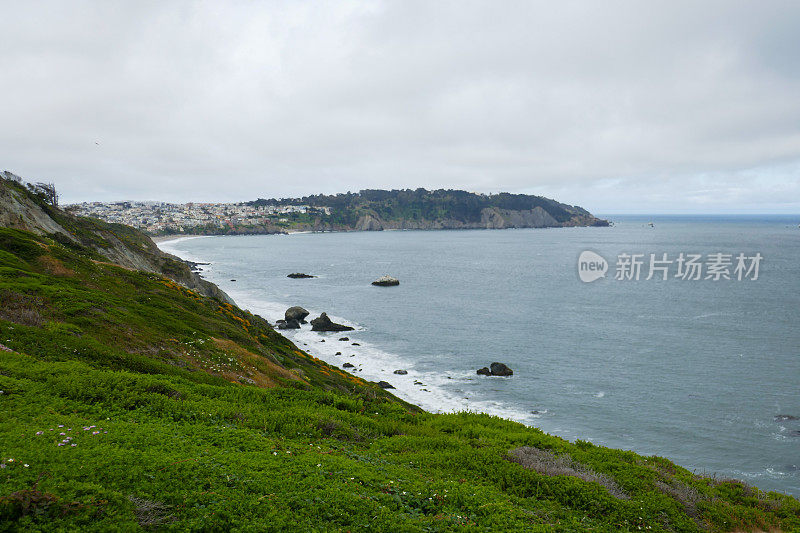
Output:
[161, 216, 800, 495]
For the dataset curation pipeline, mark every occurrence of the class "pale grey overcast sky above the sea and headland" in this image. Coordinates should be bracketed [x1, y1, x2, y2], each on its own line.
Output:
[0, 0, 800, 213]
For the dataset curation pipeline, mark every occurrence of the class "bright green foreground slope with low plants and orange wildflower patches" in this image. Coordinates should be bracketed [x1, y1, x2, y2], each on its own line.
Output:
[0, 229, 800, 531]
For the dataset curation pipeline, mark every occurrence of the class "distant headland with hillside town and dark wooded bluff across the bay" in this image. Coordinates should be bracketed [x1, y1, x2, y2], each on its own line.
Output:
[68, 188, 608, 235]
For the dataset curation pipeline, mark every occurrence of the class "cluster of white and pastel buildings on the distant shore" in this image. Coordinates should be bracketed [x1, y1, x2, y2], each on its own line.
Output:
[68, 202, 322, 233]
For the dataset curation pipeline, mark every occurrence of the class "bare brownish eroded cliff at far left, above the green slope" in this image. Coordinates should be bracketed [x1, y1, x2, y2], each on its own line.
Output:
[0, 177, 233, 303]
